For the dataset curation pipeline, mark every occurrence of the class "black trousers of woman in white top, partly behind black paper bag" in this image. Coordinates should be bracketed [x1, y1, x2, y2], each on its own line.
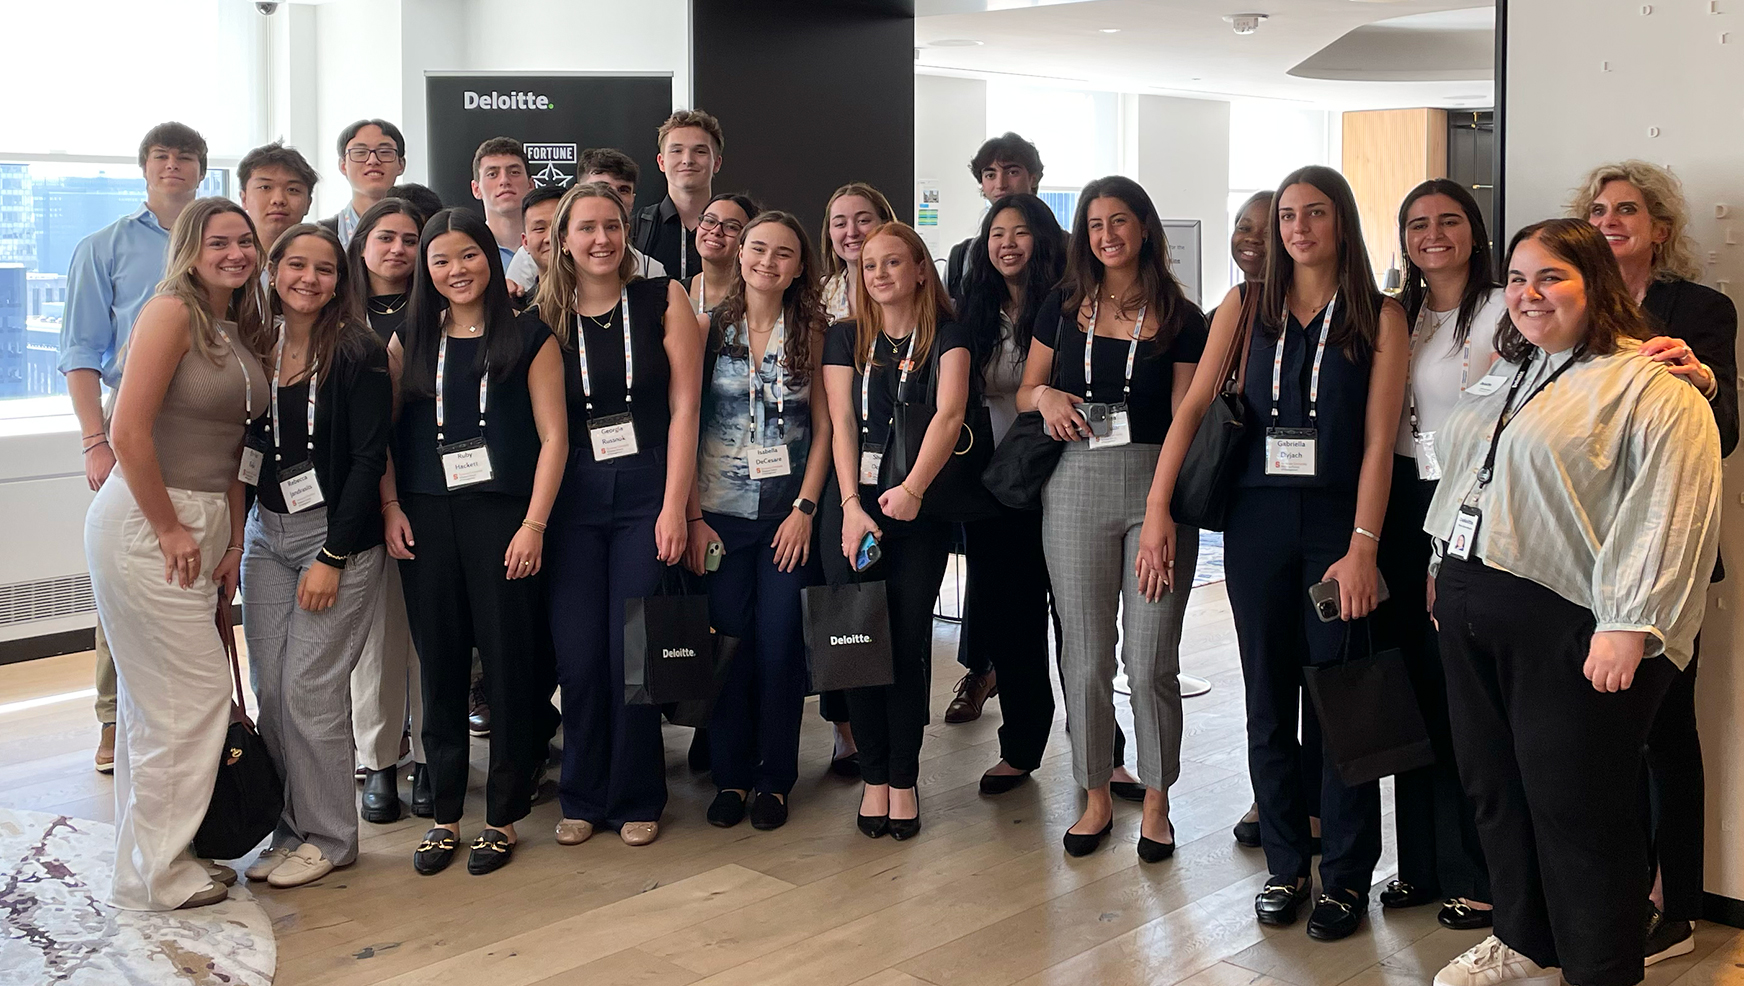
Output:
[1374, 455, 1489, 904]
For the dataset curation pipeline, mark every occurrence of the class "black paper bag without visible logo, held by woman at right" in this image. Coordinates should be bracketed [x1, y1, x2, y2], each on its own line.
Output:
[1303, 618, 1435, 787]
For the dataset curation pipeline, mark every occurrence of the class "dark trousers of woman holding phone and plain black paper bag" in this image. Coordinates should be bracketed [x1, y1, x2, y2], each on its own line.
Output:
[1223, 487, 1381, 895]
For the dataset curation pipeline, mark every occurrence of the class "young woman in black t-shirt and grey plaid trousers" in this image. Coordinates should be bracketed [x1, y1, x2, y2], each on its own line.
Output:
[1017, 176, 1205, 862]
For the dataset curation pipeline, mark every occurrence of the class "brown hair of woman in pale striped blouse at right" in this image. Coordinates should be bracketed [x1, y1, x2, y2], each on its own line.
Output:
[1496, 220, 1653, 363]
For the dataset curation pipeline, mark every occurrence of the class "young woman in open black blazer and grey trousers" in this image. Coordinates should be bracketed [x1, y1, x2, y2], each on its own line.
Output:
[242, 223, 388, 887]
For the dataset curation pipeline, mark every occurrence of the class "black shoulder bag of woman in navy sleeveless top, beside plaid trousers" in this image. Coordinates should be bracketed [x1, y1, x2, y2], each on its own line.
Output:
[1168, 284, 1259, 531]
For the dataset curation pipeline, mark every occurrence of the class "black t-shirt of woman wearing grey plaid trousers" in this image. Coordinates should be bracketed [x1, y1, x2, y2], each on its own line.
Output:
[1034, 291, 1209, 445]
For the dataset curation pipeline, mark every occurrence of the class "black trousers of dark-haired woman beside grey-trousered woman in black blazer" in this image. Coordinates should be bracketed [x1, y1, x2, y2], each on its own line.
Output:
[399, 492, 558, 825]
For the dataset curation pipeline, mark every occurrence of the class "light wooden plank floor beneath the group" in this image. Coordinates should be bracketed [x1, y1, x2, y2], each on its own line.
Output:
[0, 585, 1744, 986]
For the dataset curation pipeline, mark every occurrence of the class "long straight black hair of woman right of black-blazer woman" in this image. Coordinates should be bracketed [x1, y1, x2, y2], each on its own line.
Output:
[399, 209, 521, 396]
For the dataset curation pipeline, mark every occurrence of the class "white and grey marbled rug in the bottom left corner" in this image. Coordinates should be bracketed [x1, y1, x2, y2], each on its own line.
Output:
[0, 808, 277, 986]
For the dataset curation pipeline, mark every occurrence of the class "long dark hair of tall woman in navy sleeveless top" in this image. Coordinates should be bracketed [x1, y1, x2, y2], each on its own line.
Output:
[1259, 164, 1386, 359]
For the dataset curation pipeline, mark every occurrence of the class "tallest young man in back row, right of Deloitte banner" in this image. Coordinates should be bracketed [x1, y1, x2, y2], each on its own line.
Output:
[635, 110, 726, 279]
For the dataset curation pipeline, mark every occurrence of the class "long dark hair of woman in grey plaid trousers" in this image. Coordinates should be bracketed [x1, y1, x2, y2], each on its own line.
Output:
[1060, 175, 1191, 353]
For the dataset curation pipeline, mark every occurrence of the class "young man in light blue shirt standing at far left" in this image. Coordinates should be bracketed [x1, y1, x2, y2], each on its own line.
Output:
[61, 122, 206, 773]
